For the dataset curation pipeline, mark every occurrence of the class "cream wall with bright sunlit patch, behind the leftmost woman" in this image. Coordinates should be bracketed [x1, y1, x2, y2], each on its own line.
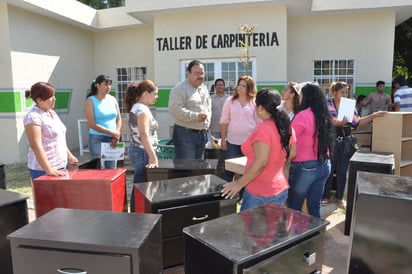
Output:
[0, 6, 95, 163]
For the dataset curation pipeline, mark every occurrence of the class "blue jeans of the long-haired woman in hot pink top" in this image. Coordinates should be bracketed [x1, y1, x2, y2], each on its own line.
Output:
[288, 159, 330, 218]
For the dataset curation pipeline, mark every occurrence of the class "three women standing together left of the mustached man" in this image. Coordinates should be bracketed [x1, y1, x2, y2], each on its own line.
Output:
[23, 75, 158, 212]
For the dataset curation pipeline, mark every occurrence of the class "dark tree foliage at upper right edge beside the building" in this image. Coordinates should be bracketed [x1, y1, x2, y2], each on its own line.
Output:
[393, 17, 412, 80]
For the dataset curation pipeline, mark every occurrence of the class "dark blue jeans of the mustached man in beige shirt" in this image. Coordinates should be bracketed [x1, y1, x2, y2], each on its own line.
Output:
[173, 125, 207, 159]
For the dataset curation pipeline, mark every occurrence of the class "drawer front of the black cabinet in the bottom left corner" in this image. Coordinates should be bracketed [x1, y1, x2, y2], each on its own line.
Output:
[12, 247, 130, 274]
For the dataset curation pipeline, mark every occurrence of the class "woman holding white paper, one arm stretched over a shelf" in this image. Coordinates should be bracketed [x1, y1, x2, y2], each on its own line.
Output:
[322, 82, 385, 209]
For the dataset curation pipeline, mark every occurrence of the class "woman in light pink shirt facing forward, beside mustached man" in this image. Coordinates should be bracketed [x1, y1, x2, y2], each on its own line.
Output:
[220, 76, 259, 181]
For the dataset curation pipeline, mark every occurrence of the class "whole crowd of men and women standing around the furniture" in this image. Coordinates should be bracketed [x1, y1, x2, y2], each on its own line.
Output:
[24, 60, 407, 217]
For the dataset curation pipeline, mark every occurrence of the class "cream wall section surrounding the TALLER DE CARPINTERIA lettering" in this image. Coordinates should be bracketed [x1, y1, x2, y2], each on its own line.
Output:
[150, 7, 287, 138]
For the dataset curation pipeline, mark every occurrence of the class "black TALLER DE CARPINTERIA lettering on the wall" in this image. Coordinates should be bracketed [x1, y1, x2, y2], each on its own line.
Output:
[156, 32, 279, 51]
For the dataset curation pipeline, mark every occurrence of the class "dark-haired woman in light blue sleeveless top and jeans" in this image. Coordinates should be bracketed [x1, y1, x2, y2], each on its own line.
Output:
[84, 75, 122, 168]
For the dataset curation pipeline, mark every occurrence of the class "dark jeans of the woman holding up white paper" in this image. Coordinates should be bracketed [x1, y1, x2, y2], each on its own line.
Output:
[323, 140, 351, 200]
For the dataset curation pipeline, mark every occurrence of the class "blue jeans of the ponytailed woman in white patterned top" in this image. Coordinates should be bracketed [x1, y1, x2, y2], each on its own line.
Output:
[129, 145, 149, 212]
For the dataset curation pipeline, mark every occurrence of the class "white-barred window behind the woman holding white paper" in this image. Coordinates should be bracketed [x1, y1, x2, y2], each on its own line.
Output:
[313, 59, 355, 98]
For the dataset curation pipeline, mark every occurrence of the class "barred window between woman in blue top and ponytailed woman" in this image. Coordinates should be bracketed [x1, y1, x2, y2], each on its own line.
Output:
[116, 67, 146, 113]
